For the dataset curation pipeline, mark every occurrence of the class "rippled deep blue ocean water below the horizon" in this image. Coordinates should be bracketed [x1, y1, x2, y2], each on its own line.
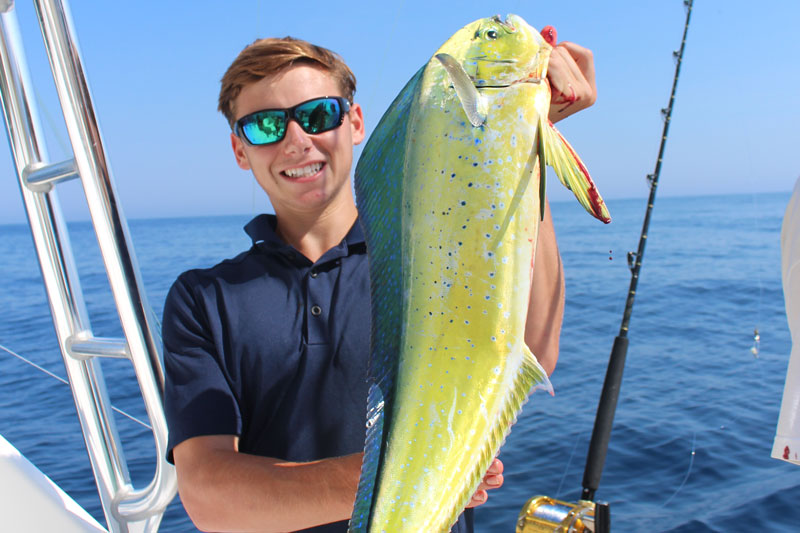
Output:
[0, 192, 800, 532]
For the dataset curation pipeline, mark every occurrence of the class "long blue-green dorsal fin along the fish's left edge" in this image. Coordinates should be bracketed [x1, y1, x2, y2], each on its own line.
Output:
[348, 67, 425, 533]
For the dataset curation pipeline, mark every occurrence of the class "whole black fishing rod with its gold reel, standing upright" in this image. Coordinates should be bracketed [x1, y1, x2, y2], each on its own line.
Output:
[516, 0, 693, 533]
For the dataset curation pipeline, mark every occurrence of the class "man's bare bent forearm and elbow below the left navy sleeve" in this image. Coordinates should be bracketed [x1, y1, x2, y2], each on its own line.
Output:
[173, 435, 362, 531]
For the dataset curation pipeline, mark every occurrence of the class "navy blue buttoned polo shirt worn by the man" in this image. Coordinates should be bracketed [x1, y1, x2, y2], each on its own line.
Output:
[162, 215, 472, 532]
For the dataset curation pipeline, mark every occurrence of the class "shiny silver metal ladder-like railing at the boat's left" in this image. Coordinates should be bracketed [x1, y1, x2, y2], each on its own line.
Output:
[0, 0, 177, 532]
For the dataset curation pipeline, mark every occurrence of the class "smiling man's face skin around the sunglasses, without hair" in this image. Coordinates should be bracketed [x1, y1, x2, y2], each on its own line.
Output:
[231, 65, 364, 219]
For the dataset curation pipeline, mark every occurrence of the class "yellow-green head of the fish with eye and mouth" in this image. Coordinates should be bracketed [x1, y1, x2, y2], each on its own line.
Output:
[451, 15, 552, 88]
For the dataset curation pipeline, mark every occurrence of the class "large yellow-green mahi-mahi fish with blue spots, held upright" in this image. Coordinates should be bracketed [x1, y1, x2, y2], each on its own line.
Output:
[350, 15, 610, 533]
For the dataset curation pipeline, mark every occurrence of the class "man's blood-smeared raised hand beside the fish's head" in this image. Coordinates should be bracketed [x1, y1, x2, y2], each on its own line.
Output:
[547, 39, 597, 123]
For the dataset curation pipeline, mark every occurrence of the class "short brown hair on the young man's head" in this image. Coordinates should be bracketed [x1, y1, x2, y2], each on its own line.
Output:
[217, 37, 356, 127]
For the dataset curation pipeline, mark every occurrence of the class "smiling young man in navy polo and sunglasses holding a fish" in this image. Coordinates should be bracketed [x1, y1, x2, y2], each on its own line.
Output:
[163, 34, 595, 532]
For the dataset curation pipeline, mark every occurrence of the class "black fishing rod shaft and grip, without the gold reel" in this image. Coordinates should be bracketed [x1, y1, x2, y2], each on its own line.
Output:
[581, 0, 693, 501]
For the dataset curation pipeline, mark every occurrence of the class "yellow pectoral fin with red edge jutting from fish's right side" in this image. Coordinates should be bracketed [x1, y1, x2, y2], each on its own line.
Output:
[540, 120, 611, 224]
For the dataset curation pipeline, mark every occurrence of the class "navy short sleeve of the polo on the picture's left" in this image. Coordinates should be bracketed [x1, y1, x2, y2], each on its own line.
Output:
[162, 272, 241, 462]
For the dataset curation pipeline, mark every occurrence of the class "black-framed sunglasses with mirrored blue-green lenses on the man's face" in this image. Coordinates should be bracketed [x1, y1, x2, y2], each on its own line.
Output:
[233, 96, 350, 146]
